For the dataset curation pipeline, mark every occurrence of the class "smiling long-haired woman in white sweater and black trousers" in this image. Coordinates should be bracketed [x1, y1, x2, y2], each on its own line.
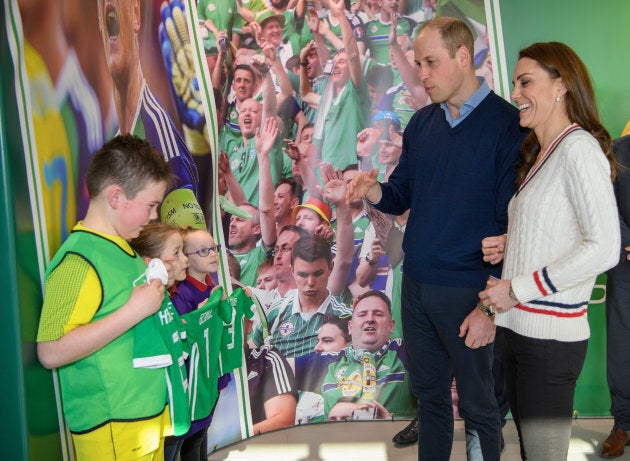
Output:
[480, 42, 620, 461]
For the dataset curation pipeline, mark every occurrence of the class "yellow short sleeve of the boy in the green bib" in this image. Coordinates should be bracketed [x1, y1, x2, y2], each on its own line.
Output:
[37, 253, 103, 342]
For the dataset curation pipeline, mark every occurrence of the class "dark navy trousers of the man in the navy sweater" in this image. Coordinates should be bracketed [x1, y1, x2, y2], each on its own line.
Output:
[402, 276, 501, 461]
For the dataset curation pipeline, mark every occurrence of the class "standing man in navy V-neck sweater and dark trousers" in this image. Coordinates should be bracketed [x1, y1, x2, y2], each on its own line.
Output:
[348, 17, 526, 461]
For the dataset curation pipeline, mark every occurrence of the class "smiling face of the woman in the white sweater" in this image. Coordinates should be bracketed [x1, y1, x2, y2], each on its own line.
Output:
[510, 58, 566, 130]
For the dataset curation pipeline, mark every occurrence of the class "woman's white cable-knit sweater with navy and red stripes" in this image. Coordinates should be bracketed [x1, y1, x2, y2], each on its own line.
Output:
[496, 125, 621, 341]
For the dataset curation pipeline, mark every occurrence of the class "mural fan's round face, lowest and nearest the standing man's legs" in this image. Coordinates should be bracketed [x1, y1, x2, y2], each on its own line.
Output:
[348, 296, 394, 352]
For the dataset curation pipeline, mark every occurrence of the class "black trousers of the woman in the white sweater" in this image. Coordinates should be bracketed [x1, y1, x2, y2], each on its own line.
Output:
[503, 330, 588, 461]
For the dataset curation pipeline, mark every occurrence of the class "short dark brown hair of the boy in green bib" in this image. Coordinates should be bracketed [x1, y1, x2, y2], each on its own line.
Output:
[86, 134, 173, 199]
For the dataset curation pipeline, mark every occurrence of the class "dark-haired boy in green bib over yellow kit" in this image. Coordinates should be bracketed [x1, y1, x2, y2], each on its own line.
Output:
[37, 135, 171, 460]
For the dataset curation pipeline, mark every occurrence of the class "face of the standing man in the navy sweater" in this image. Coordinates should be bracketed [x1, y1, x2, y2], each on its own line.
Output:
[414, 27, 469, 103]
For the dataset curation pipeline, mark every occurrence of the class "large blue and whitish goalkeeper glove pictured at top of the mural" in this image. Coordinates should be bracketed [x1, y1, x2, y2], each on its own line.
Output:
[158, 0, 205, 131]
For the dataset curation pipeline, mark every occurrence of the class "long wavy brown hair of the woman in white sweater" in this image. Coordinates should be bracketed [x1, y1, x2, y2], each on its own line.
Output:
[516, 42, 617, 187]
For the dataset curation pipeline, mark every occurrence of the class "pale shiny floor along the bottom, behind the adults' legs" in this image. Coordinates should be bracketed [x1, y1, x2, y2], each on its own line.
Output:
[208, 418, 630, 461]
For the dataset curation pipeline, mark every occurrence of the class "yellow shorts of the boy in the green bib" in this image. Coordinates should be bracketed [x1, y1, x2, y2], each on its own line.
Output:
[72, 408, 170, 461]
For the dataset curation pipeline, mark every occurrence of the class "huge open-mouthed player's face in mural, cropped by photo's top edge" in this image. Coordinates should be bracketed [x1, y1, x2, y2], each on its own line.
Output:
[98, 0, 141, 83]
